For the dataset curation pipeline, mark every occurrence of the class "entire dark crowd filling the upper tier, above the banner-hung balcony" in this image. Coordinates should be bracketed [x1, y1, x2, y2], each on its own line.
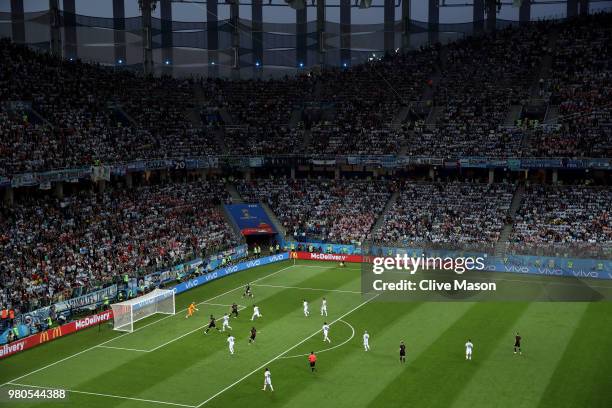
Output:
[0, 14, 612, 175]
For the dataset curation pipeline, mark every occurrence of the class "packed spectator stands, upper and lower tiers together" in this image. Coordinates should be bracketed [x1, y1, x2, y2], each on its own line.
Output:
[0, 14, 612, 332]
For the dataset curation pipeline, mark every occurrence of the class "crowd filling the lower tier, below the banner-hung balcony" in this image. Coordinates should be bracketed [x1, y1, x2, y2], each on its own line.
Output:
[0, 172, 612, 328]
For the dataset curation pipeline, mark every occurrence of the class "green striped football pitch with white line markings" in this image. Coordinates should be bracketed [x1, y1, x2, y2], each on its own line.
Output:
[0, 261, 612, 408]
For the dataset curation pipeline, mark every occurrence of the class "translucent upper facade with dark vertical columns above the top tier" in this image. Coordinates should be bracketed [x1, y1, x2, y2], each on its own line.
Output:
[0, 0, 612, 77]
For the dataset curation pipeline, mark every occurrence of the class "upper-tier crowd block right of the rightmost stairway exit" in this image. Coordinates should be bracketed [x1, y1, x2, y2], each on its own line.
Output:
[528, 14, 612, 157]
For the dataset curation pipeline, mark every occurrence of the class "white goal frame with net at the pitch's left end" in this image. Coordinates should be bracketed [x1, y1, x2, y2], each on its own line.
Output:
[111, 289, 175, 332]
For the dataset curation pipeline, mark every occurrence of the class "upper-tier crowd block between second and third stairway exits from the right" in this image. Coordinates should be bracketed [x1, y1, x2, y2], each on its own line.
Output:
[306, 46, 439, 154]
